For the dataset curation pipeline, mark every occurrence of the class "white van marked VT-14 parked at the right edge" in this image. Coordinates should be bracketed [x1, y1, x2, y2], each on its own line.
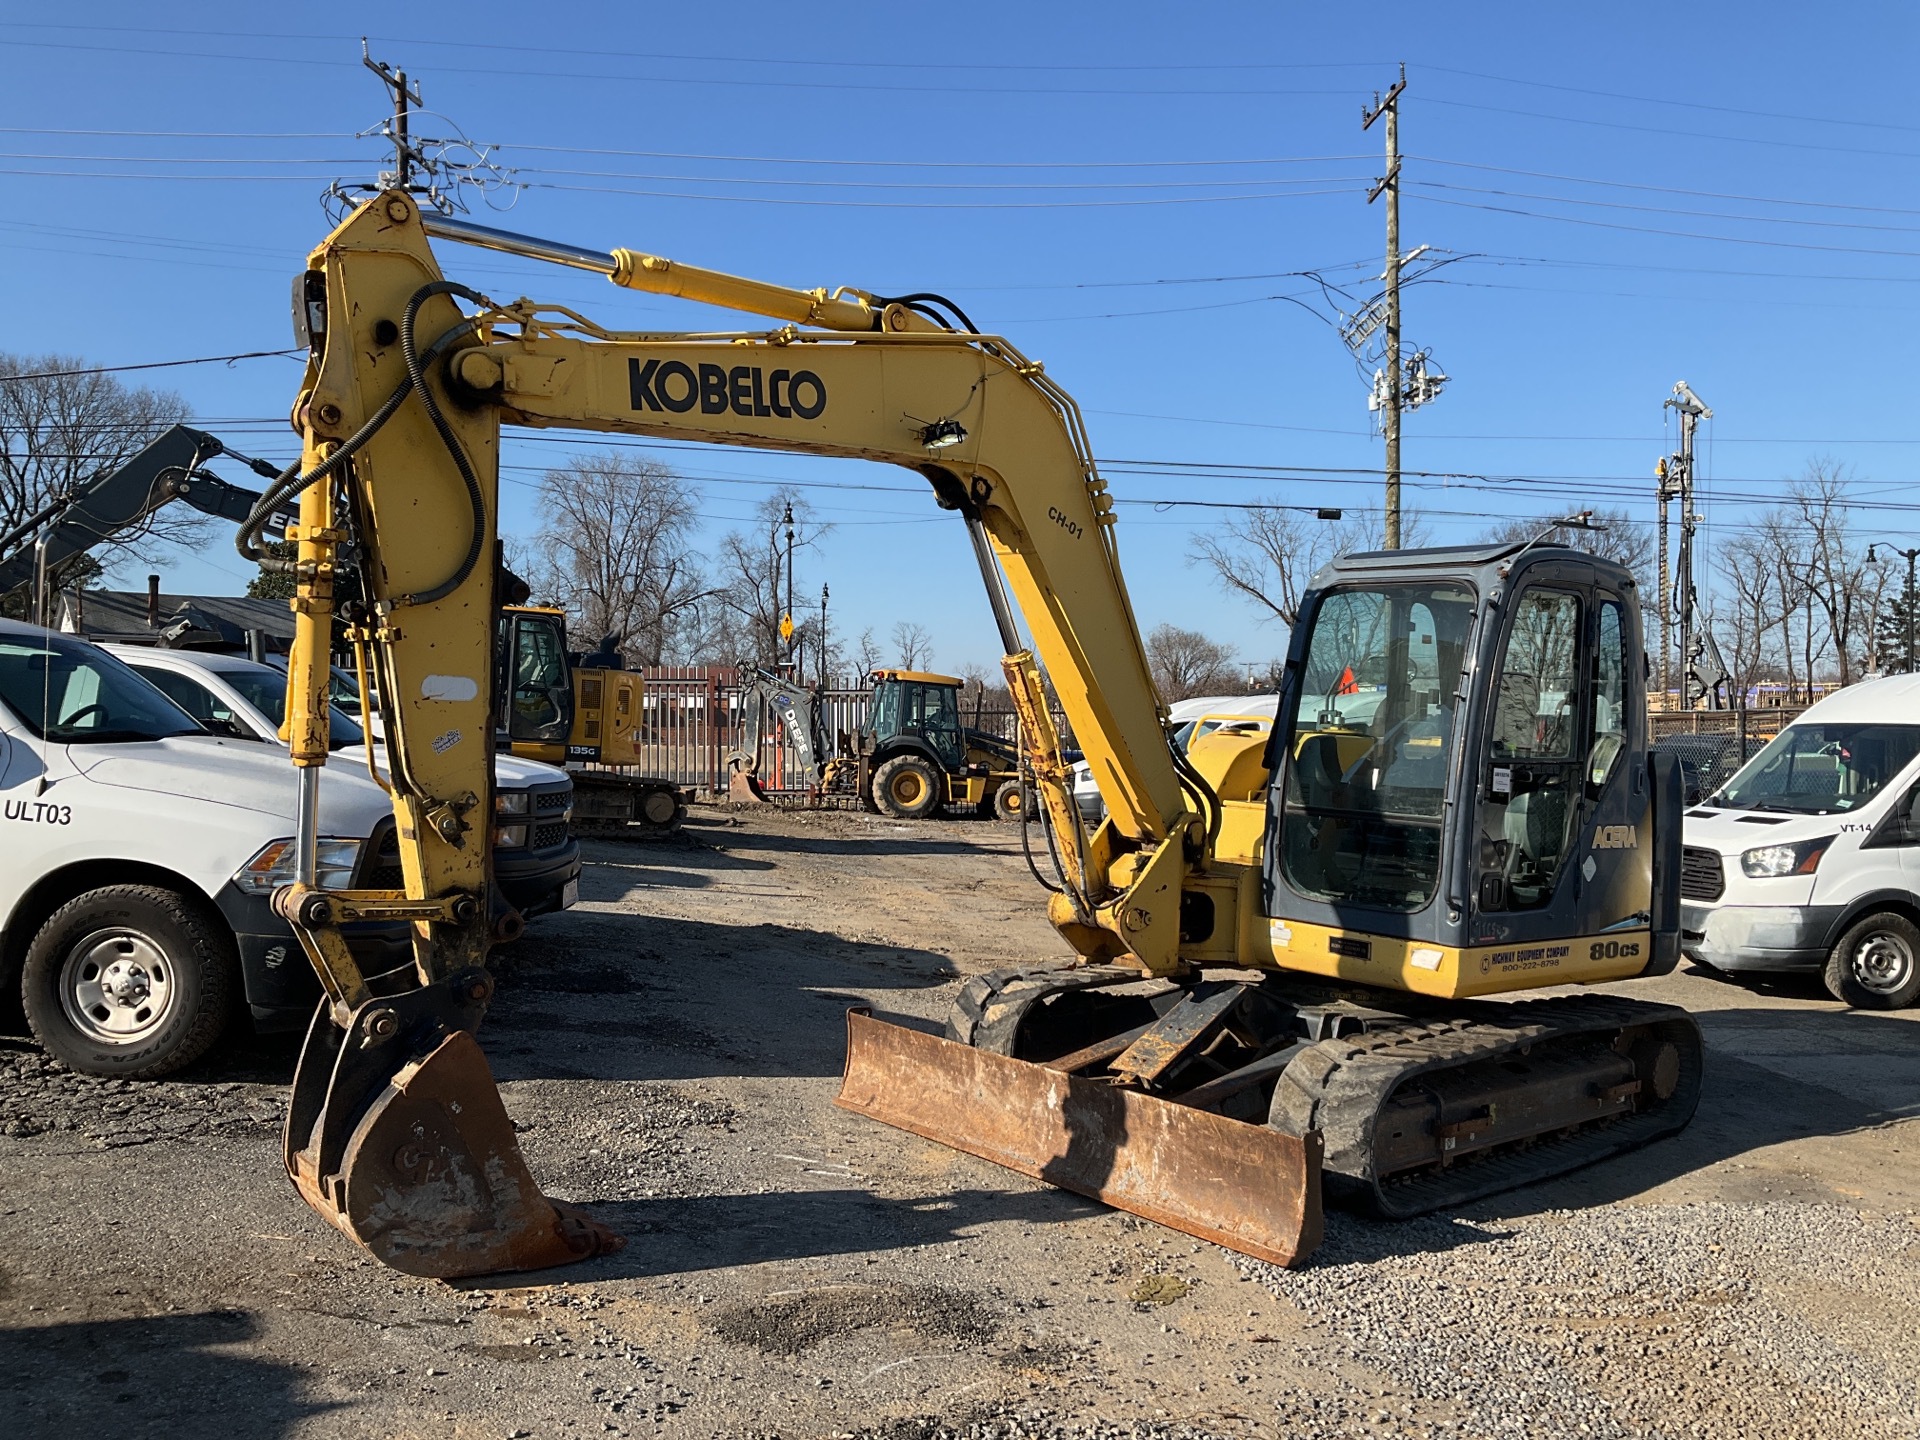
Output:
[1680, 676, 1920, 1010]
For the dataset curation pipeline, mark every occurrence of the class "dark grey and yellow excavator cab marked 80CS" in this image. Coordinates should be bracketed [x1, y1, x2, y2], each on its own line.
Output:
[1265, 545, 1678, 998]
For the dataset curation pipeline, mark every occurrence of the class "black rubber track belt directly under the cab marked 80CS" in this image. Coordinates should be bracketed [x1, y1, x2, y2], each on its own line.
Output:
[1269, 995, 1701, 1219]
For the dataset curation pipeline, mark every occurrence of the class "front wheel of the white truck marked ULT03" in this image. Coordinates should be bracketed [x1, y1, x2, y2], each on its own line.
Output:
[19, 885, 238, 1079]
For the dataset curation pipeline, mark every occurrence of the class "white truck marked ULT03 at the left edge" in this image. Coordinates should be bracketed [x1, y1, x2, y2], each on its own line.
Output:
[0, 620, 411, 1079]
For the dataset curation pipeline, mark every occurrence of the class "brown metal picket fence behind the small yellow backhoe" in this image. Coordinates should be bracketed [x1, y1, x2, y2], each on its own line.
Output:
[591, 666, 1066, 795]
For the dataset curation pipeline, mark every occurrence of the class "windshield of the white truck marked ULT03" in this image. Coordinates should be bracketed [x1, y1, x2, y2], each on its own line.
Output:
[0, 636, 205, 745]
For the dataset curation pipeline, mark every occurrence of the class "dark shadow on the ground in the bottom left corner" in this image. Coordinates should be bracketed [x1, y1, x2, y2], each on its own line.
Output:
[0, 1309, 336, 1440]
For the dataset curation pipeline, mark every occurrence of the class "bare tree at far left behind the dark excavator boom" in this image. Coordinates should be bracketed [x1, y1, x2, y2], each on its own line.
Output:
[0, 351, 196, 583]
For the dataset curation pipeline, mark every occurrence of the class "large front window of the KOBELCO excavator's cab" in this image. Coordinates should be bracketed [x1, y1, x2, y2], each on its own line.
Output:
[1281, 582, 1473, 912]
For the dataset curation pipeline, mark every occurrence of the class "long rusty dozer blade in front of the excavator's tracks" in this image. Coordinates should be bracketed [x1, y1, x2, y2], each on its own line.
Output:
[835, 1008, 1321, 1265]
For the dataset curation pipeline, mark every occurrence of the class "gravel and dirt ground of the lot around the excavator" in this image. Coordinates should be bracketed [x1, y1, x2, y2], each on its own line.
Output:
[0, 810, 1920, 1440]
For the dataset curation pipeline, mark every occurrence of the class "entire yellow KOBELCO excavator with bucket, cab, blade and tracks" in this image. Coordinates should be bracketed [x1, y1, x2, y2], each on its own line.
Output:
[242, 192, 1701, 1275]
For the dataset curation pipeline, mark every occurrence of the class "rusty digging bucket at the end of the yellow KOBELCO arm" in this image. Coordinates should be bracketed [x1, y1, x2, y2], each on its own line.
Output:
[286, 970, 624, 1279]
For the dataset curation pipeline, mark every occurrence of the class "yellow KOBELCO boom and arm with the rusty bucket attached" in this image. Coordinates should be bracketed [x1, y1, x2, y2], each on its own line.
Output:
[255, 192, 1267, 1275]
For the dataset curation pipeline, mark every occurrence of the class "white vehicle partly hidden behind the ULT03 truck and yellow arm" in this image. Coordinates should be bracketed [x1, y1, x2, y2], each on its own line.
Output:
[102, 645, 580, 916]
